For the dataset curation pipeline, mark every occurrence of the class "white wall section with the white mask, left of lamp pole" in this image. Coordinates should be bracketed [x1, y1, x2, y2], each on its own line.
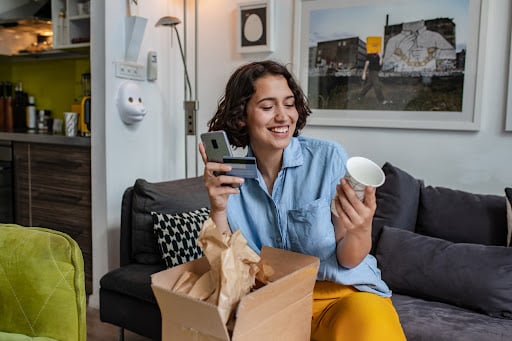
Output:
[90, 0, 184, 306]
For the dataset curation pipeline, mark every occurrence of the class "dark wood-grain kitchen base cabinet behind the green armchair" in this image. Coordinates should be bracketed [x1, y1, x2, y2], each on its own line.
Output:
[13, 142, 92, 294]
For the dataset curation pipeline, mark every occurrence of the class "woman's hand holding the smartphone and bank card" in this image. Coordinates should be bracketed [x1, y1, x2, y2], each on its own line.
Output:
[199, 143, 244, 231]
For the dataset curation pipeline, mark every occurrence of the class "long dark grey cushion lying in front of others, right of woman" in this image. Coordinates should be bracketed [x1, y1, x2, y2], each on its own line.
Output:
[376, 226, 512, 319]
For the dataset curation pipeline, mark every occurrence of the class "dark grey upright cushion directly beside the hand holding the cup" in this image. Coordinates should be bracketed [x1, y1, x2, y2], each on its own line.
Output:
[372, 162, 423, 245]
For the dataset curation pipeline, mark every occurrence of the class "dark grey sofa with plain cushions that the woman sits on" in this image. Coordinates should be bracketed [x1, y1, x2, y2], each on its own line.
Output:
[100, 163, 512, 341]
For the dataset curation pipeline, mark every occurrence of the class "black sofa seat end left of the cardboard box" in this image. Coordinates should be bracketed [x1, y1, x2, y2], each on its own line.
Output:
[100, 264, 165, 304]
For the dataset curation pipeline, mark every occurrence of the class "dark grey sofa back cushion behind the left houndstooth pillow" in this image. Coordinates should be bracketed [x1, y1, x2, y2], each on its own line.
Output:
[131, 177, 210, 264]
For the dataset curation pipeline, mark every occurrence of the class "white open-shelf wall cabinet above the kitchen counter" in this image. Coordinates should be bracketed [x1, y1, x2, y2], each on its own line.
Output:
[52, 0, 91, 49]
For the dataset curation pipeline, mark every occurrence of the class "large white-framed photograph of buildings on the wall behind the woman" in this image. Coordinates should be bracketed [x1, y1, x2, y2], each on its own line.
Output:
[293, 0, 484, 130]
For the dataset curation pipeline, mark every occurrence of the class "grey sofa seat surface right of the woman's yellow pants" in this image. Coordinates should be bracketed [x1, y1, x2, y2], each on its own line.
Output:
[391, 294, 512, 341]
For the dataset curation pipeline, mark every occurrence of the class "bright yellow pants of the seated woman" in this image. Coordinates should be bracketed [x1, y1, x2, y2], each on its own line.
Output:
[311, 281, 406, 341]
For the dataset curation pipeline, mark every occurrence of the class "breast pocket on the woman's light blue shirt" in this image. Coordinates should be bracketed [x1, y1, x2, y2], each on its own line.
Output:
[287, 198, 336, 259]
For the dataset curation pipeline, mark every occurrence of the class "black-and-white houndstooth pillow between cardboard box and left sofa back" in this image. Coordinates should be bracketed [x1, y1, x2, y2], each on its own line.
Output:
[151, 207, 210, 268]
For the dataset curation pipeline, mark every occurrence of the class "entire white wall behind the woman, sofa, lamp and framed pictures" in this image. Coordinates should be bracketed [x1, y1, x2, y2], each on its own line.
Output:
[90, 0, 512, 306]
